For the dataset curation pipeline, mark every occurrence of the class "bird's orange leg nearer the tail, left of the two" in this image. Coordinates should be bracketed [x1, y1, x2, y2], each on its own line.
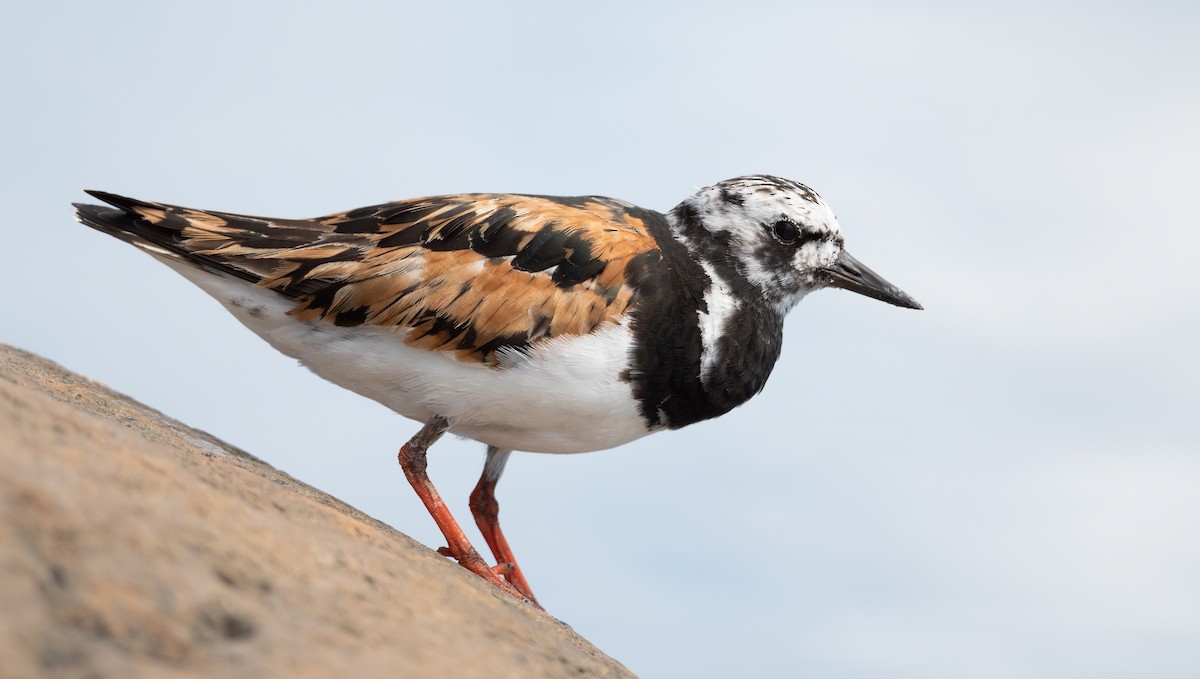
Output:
[398, 417, 526, 607]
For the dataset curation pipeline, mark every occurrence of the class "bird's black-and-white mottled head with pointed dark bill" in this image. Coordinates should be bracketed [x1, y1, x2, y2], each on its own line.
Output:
[671, 175, 922, 313]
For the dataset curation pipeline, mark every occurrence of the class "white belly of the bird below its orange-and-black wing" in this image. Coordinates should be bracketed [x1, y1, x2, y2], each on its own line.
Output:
[163, 259, 649, 452]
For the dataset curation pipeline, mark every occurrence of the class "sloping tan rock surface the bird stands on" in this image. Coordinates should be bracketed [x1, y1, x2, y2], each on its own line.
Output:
[0, 345, 632, 679]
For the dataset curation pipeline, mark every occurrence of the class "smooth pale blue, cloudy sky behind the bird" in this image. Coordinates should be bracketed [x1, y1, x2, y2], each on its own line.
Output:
[0, 1, 1200, 679]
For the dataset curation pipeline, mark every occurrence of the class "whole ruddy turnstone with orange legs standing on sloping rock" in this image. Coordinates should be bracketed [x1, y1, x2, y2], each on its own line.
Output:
[76, 175, 920, 602]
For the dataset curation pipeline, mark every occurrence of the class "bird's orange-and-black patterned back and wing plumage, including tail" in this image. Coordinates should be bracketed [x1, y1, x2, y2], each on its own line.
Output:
[77, 191, 662, 365]
